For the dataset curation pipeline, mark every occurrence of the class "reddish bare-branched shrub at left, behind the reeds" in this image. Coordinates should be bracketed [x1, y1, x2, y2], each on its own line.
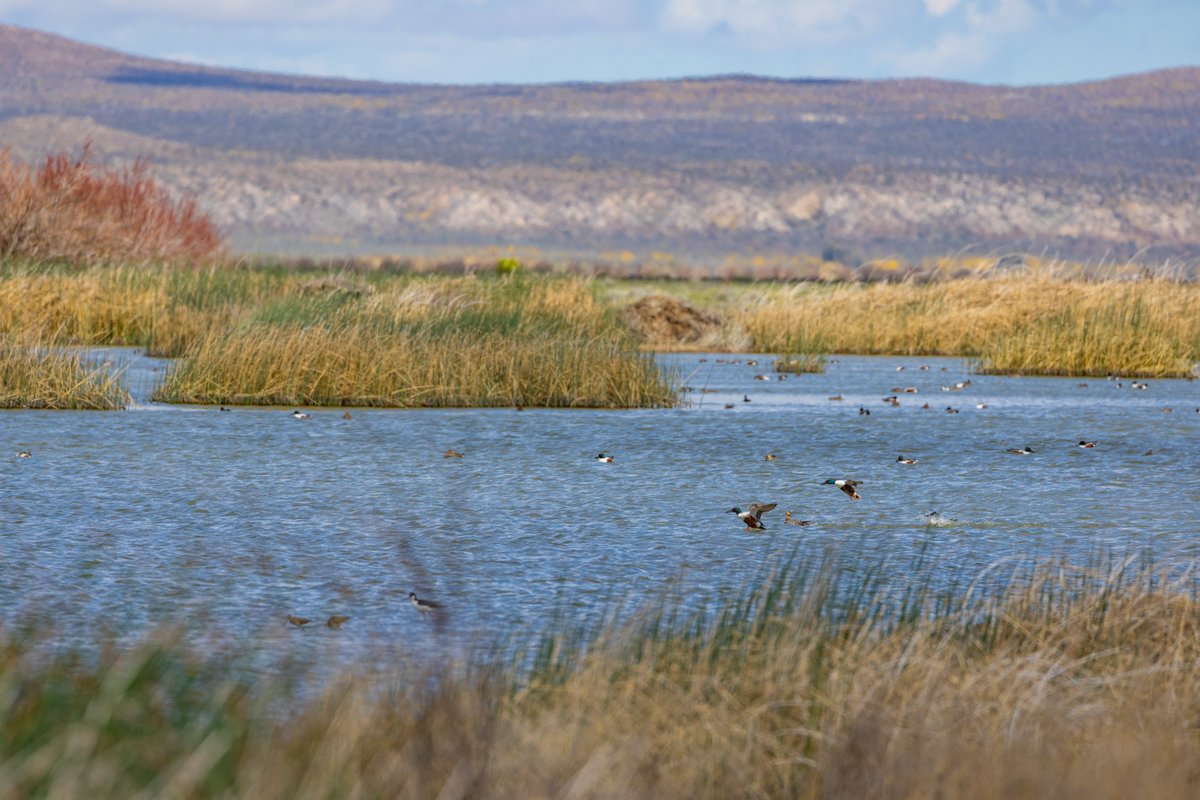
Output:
[0, 145, 224, 261]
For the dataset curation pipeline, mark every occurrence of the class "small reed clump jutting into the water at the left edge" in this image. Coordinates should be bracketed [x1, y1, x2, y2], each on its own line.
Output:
[0, 337, 130, 410]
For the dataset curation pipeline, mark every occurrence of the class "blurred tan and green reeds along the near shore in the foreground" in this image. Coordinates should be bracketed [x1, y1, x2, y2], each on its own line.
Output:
[7, 564, 1200, 800]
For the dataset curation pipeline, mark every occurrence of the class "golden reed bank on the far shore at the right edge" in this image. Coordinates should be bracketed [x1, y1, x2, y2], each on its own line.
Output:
[742, 276, 1200, 377]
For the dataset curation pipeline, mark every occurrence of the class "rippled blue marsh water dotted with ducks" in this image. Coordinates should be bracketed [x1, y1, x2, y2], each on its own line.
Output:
[0, 351, 1200, 671]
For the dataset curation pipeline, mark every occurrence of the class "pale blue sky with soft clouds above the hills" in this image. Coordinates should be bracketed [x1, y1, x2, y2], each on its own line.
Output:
[0, 0, 1200, 84]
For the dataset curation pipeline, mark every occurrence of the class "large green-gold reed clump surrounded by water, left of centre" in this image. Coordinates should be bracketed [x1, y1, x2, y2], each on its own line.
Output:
[156, 273, 674, 408]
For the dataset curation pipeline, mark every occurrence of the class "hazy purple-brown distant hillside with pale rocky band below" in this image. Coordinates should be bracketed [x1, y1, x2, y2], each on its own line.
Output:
[0, 26, 1200, 260]
